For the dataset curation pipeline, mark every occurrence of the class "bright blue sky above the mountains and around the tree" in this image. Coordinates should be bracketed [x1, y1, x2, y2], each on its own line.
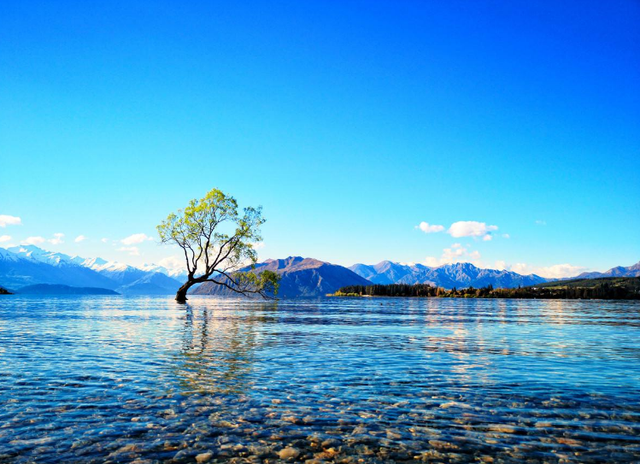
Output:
[0, 0, 640, 276]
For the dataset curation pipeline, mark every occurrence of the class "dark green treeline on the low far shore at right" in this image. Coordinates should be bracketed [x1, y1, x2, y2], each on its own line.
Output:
[329, 277, 640, 300]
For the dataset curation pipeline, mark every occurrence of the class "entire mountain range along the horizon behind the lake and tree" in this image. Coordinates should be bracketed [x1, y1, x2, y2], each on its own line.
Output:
[0, 245, 640, 297]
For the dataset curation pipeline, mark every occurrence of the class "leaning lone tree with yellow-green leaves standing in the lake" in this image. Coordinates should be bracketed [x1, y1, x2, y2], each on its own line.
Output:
[157, 189, 280, 303]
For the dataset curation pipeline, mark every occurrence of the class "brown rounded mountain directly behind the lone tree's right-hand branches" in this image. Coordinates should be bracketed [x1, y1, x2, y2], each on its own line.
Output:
[193, 256, 371, 298]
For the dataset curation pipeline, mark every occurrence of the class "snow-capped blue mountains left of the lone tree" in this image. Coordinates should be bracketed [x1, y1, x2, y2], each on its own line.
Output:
[0, 245, 181, 295]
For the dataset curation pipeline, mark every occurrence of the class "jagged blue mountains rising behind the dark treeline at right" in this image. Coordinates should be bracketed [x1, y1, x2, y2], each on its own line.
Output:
[349, 261, 547, 289]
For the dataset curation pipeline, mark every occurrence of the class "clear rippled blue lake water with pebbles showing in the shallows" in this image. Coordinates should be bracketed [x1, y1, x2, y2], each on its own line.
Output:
[0, 296, 640, 463]
